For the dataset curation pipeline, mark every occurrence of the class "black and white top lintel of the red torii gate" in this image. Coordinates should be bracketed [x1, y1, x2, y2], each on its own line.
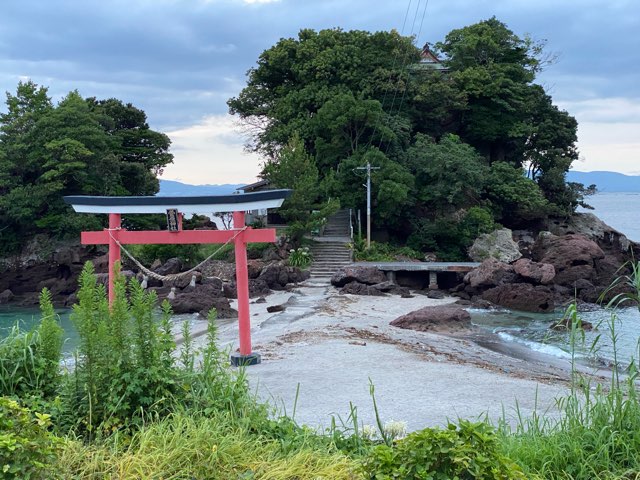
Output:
[64, 190, 291, 214]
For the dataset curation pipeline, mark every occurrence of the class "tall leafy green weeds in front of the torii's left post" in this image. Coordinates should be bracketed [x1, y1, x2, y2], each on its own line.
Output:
[63, 262, 177, 436]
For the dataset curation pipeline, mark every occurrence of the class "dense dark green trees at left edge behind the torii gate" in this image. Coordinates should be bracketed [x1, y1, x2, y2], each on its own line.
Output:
[0, 81, 173, 253]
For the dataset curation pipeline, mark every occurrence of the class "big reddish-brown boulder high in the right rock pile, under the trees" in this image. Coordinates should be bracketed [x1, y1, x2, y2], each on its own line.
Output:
[533, 232, 605, 287]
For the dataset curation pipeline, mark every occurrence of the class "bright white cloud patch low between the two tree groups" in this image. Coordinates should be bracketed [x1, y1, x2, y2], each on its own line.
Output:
[162, 115, 261, 185]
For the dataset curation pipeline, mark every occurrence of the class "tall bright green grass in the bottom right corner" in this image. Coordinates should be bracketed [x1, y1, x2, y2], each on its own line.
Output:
[500, 294, 640, 480]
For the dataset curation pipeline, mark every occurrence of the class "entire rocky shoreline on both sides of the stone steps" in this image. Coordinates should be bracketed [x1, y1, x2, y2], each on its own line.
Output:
[0, 213, 640, 318]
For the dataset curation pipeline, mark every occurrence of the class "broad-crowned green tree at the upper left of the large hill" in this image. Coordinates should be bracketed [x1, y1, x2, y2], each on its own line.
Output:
[227, 29, 419, 156]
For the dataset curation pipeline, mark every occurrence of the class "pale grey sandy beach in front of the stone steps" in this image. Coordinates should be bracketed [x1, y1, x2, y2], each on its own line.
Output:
[181, 282, 600, 430]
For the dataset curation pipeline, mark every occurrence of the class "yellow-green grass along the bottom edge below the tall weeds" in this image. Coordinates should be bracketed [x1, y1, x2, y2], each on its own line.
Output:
[59, 412, 357, 480]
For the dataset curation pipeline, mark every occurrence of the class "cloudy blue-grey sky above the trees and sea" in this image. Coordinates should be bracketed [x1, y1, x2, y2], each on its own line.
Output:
[0, 0, 640, 184]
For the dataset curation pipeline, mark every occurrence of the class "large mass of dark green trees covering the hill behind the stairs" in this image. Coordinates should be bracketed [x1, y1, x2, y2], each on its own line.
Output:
[228, 18, 589, 259]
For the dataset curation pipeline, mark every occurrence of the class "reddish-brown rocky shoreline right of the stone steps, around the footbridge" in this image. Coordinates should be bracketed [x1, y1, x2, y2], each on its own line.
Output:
[332, 213, 640, 313]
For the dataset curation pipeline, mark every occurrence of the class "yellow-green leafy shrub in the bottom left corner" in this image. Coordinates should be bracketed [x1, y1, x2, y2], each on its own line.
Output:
[0, 397, 60, 479]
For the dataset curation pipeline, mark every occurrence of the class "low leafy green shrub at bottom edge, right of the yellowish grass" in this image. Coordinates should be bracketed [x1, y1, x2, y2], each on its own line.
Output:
[364, 420, 526, 480]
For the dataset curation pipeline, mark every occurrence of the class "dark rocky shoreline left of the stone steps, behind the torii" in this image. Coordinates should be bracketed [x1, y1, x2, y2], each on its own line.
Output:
[0, 238, 309, 318]
